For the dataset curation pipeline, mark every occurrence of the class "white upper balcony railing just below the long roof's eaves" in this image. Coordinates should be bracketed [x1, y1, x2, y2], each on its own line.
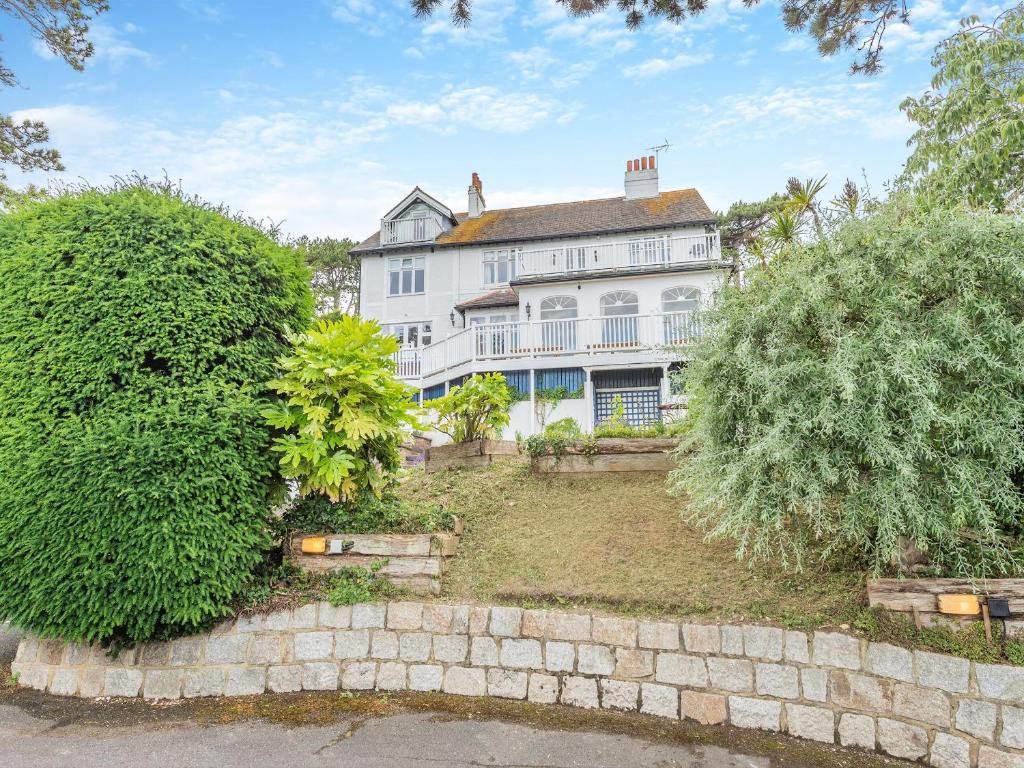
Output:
[516, 232, 722, 280]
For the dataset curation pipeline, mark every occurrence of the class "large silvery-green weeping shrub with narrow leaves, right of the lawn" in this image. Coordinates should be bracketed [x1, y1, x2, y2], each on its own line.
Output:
[674, 199, 1024, 575]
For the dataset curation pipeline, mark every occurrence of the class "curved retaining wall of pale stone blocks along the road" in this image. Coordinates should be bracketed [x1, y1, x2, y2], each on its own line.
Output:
[13, 602, 1024, 768]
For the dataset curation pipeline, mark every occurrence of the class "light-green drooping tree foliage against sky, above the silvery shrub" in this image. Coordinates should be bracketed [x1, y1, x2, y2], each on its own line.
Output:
[900, 4, 1024, 210]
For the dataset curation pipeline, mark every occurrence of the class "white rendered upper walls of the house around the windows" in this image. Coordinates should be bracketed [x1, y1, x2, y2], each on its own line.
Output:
[360, 226, 722, 343]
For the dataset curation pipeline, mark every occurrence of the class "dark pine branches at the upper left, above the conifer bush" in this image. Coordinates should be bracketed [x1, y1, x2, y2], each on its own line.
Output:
[0, 0, 110, 195]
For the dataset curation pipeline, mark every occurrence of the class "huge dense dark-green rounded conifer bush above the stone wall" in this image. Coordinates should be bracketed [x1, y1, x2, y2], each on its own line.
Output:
[0, 182, 312, 643]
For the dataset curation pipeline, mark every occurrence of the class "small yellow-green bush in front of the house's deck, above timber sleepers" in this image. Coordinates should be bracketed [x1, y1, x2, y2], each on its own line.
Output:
[423, 374, 512, 442]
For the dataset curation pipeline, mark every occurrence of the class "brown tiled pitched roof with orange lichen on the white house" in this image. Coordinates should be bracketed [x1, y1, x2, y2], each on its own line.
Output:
[352, 189, 715, 253]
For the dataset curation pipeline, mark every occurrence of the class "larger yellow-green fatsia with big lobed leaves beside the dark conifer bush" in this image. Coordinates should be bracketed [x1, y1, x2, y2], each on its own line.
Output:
[263, 316, 418, 502]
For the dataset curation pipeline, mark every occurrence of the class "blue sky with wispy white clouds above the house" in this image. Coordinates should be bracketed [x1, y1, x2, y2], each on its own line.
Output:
[0, 0, 994, 240]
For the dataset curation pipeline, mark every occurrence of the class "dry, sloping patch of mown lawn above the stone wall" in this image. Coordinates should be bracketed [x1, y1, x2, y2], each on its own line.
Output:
[400, 460, 864, 626]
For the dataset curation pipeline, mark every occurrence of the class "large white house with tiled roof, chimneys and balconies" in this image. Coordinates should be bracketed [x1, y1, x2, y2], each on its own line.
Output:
[352, 156, 730, 434]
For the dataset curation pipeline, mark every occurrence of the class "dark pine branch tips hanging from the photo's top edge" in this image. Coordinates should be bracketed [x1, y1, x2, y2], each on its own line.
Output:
[411, 0, 910, 75]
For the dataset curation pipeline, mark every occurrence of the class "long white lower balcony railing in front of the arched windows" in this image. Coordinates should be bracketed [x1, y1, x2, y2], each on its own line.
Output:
[399, 312, 700, 378]
